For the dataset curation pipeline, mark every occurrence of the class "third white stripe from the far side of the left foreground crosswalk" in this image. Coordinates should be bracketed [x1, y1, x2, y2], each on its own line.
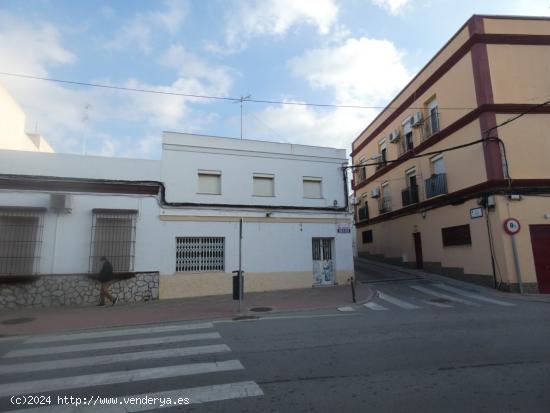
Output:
[0, 344, 231, 374]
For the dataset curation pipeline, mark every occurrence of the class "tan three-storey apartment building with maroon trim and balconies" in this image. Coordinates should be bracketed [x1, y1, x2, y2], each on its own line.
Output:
[352, 15, 550, 293]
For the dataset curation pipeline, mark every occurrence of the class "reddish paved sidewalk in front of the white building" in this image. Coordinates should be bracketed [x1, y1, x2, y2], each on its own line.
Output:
[0, 283, 368, 337]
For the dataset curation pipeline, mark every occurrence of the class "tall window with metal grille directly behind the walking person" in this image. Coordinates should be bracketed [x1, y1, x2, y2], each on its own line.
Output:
[89, 209, 137, 272]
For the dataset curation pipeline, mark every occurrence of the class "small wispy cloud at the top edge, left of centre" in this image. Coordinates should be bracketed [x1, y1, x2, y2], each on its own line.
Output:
[102, 0, 187, 54]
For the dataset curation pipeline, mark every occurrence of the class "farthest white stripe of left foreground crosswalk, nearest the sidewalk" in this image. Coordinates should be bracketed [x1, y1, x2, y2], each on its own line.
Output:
[25, 323, 214, 343]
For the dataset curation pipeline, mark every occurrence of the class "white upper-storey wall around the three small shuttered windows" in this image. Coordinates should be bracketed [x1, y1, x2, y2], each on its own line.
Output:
[162, 133, 346, 207]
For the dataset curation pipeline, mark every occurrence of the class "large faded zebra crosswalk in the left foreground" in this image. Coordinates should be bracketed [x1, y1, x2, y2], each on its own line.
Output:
[0, 323, 263, 413]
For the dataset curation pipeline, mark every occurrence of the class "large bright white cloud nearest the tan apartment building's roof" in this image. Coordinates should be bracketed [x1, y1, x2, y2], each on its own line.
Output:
[289, 37, 410, 105]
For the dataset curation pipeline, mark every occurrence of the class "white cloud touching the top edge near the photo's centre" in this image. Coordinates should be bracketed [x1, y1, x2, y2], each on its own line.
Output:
[212, 0, 338, 52]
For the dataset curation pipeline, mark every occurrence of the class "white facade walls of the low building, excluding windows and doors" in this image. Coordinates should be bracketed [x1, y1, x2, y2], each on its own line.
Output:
[0, 133, 353, 298]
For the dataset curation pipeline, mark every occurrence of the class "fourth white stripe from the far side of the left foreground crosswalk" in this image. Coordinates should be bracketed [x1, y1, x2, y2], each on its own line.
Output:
[0, 360, 244, 397]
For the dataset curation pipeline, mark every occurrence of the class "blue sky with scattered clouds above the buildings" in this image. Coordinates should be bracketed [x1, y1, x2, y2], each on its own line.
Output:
[0, 0, 550, 159]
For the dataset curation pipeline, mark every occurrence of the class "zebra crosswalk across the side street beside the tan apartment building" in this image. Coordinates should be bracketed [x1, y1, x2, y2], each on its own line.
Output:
[364, 283, 515, 311]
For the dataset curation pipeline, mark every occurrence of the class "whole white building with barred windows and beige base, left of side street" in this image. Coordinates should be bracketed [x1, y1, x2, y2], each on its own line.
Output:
[0, 133, 353, 304]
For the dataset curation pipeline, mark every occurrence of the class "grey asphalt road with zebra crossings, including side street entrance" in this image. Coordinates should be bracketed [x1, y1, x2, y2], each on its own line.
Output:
[0, 262, 550, 413]
